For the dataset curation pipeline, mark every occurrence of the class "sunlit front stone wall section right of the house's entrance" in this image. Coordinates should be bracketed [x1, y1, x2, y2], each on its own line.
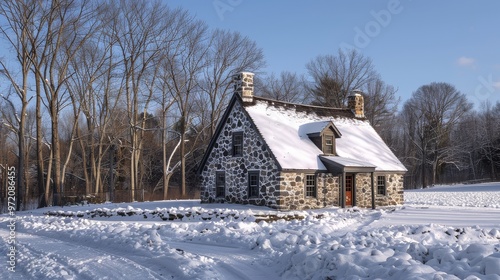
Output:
[356, 173, 404, 208]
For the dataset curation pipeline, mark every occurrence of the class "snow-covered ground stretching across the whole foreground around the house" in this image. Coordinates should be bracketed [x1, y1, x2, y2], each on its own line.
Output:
[0, 183, 500, 279]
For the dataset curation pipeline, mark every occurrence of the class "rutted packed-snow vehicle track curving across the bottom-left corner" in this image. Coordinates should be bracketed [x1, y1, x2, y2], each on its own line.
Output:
[0, 229, 166, 279]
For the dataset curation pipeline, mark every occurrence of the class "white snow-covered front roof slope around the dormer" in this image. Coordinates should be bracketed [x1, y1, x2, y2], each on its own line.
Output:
[245, 98, 406, 172]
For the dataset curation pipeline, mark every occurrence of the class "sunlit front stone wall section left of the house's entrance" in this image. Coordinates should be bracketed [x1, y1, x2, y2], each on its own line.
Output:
[277, 172, 339, 210]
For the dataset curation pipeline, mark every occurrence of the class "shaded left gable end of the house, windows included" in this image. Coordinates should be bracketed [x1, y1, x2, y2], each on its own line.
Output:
[198, 93, 281, 207]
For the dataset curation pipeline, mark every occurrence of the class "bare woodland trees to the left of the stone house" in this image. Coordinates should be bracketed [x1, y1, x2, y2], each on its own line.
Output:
[0, 0, 264, 209]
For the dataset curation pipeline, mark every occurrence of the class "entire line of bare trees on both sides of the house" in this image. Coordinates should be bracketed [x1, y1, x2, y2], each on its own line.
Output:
[0, 0, 500, 210]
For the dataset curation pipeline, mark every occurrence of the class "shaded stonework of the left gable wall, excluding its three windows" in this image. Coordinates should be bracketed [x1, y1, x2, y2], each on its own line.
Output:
[200, 102, 279, 208]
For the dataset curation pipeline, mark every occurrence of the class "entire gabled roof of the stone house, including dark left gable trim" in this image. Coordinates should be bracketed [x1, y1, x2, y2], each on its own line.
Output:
[198, 94, 407, 172]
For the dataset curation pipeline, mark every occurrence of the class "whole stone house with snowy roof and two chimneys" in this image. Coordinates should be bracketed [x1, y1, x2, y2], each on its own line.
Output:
[199, 72, 406, 210]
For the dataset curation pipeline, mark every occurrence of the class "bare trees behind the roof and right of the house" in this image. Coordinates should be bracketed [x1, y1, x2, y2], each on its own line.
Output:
[261, 50, 500, 188]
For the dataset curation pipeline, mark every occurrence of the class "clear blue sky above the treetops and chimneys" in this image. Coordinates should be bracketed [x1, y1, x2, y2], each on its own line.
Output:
[168, 0, 500, 106]
